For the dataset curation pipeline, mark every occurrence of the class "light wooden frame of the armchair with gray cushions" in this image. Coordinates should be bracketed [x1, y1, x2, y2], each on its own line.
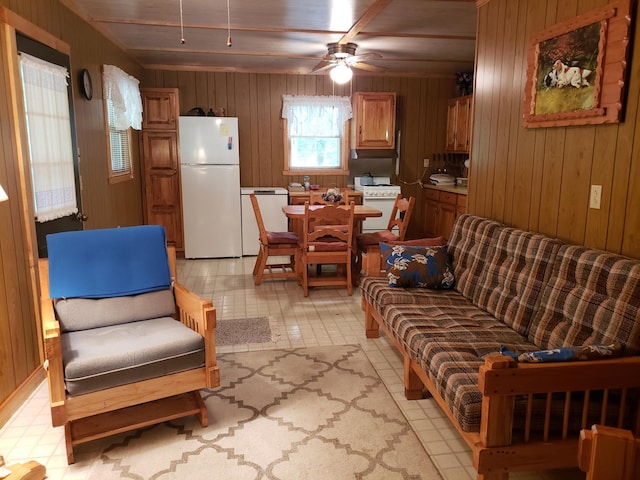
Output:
[39, 247, 220, 464]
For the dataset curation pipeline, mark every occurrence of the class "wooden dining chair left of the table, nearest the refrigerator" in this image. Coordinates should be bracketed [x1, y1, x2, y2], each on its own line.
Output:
[249, 193, 299, 285]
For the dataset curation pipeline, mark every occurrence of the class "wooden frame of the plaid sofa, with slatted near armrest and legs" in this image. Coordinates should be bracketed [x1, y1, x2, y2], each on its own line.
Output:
[362, 298, 640, 480]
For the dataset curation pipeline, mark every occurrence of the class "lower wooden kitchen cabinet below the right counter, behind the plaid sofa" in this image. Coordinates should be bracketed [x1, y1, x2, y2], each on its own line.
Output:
[424, 188, 467, 240]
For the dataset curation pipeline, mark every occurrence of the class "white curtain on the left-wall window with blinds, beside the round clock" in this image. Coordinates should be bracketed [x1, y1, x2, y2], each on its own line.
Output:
[102, 65, 142, 130]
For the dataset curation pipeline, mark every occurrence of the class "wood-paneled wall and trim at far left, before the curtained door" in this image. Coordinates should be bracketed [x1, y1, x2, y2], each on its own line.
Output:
[0, 17, 41, 408]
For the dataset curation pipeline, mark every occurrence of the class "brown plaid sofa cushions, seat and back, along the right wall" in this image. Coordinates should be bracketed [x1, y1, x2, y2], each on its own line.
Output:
[361, 215, 640, 438]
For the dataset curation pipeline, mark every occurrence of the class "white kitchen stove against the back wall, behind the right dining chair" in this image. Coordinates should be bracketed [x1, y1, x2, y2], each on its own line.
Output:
[353, 177, 401, 232]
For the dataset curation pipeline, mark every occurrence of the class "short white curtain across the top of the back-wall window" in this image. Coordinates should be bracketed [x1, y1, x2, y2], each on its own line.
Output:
[282, 95, 353, 137]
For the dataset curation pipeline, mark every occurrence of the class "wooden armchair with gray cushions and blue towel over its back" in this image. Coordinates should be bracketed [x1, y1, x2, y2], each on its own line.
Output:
[39, 225, 220, 463]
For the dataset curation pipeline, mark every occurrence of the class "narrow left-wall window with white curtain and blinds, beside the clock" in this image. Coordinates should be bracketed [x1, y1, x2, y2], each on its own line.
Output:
[102, 65, 142, 183]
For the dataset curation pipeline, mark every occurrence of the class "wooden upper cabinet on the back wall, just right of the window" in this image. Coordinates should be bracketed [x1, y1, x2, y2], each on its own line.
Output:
[351, 92, 396, 149]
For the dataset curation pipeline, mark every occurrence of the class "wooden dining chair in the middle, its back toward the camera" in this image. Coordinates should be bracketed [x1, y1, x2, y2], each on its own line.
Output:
[298, 202, 355, 297]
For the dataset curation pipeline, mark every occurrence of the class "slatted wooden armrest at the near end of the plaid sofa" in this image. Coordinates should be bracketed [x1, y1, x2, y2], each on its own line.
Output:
[474, 356, 640, 473]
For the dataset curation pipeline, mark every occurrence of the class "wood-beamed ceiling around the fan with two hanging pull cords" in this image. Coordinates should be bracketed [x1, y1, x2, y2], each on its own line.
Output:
[61, 0, 476, 76]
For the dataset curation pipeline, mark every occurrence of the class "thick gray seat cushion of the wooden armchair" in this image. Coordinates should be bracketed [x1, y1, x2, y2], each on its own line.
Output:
[61, 317, 204, 395]
